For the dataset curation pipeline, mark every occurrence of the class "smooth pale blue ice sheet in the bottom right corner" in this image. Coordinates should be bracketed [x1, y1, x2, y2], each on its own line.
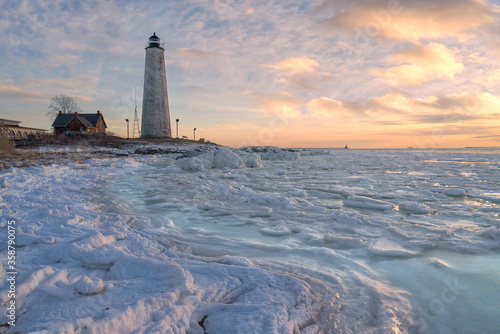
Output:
[373, 251, 500, 334]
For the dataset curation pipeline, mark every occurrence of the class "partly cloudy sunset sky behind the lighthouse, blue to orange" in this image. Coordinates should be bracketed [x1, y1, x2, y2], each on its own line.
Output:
[0, 0, 500, 148]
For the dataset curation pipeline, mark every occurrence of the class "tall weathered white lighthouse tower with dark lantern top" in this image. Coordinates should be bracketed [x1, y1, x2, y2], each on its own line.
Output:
[141, 33, 172, 138]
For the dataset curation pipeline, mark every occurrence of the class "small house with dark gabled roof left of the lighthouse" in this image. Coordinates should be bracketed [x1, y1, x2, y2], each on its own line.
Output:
[52, 110, 107, 136]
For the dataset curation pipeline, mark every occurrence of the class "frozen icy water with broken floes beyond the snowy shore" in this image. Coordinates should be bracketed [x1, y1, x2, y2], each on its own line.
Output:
[114, 149, 500, 333]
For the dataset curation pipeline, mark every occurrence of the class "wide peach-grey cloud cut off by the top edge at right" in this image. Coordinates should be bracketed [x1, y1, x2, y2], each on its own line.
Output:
[317, 0, 496, 41]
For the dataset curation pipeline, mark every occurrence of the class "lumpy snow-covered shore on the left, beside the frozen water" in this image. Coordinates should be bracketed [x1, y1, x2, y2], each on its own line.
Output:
[0, 147, 324, 333]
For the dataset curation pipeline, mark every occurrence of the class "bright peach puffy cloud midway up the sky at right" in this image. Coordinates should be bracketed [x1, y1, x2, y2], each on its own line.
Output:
[372, 43, 464, 87]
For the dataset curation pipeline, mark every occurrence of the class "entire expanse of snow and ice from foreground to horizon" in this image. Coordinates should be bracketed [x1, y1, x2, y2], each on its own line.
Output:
[0, 146, 500, 334]
